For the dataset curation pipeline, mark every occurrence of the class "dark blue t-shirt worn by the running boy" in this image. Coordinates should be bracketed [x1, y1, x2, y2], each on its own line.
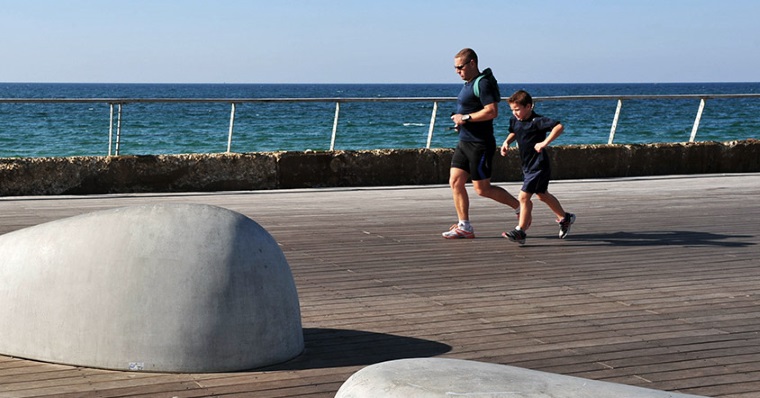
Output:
[509, 112, 559, 174]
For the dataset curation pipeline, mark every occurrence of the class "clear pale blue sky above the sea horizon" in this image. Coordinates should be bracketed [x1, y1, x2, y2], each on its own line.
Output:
[0, 0, 760, 83]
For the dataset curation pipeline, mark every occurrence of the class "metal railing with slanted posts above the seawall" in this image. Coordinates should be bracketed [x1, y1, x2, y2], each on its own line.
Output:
[0, 94, 760, 156]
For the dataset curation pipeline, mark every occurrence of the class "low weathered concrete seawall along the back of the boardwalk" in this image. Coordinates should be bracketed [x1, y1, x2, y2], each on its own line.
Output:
[0, 139, 760, 196]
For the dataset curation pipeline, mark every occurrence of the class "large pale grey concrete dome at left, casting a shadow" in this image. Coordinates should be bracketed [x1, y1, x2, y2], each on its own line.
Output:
[0, 204, 304, 372]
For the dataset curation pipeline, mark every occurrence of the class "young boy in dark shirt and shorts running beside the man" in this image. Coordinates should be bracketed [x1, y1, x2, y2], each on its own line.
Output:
[501, 90, 575, 244]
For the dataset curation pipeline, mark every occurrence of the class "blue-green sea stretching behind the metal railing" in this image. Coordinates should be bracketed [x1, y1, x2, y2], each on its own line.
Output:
[0, 83, 760, 158]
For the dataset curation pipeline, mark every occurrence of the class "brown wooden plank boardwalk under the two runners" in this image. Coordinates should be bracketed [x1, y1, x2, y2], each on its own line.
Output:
[0, 174, 760, 398]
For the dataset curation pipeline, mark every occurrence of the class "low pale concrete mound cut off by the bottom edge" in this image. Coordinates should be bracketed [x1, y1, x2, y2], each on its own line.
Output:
[335, 358, 704, 398]
